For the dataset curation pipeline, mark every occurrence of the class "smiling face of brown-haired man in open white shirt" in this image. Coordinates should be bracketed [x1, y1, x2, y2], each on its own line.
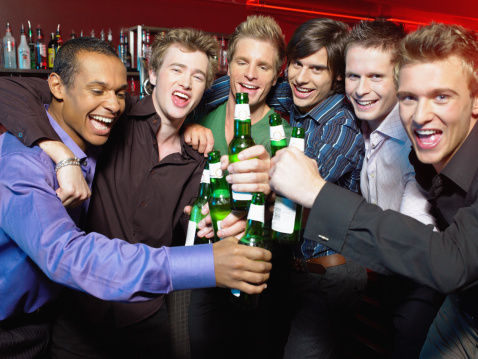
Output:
[345, 45, 397, 131]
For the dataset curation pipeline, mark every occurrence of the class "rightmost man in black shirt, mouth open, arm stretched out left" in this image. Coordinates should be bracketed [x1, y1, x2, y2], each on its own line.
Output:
[270, 24, 478, 358]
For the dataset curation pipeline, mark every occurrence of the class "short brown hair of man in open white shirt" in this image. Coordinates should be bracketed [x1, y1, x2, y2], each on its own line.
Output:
[345, 18, 407, 65]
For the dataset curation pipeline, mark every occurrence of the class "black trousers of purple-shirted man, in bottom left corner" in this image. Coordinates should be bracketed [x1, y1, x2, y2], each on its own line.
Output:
[0, 309, 52, 359]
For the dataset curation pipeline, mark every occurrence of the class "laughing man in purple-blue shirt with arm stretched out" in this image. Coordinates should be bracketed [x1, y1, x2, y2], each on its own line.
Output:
[0, 38, 270, 358]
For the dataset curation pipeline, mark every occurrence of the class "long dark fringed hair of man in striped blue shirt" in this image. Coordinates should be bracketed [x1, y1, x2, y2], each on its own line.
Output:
[286, 18, 349, 95]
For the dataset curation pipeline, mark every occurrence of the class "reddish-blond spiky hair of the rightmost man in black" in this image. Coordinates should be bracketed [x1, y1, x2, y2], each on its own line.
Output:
[395, 23, 478, 96]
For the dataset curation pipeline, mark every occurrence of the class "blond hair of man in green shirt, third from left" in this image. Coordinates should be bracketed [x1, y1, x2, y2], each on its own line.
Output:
[227, 15, 285, 75]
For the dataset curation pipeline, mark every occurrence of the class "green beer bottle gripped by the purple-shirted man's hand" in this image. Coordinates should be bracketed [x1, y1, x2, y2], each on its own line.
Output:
[231, 192, 266, 309]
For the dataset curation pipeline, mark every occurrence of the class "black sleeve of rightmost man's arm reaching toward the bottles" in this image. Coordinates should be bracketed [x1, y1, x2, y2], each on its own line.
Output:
[304, 183, 478, 293]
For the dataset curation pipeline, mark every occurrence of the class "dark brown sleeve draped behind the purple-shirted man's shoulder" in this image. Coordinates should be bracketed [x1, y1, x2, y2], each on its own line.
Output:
[0, 77, 60, 146]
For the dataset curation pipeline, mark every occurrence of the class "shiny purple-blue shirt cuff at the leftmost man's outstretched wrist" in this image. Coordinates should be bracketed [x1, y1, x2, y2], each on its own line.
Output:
[170, 244, 216, 290]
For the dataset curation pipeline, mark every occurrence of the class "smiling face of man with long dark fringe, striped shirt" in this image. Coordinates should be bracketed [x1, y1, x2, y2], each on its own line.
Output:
[288, 47, 333, 113]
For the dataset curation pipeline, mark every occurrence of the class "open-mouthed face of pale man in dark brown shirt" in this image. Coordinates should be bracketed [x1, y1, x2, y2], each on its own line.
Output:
[149, 44, 208, 122]
